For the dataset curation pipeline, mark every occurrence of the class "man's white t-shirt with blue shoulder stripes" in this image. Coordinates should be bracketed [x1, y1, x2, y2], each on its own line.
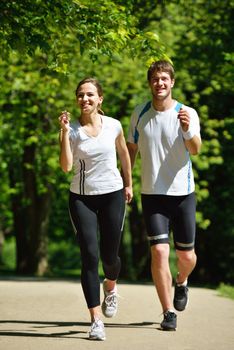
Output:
[128, 101, 200, 196]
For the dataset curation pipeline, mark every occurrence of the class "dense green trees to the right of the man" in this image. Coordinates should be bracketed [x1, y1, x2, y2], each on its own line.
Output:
[144, 0, 234, 283]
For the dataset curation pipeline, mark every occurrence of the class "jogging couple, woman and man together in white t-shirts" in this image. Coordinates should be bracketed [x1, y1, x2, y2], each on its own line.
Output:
[59, 60, 201, 340]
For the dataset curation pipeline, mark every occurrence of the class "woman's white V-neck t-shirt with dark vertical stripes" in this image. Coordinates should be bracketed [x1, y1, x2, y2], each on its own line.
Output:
[69, 116, 123, 195]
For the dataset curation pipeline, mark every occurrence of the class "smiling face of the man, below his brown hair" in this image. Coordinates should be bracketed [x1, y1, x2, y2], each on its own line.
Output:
[149, 72, 175, 100]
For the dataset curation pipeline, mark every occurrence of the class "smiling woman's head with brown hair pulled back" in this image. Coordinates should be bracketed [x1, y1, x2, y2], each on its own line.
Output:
[76, 83, 103, 114]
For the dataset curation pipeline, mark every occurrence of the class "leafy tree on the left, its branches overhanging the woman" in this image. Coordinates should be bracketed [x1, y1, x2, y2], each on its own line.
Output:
[0, 0, 165, 275]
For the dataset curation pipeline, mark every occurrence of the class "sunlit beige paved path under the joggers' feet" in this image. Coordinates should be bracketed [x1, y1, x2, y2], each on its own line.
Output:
[0, 279, 234, 350]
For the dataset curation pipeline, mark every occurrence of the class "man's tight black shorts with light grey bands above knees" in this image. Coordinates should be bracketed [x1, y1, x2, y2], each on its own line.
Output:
[141, 193, 196, 250]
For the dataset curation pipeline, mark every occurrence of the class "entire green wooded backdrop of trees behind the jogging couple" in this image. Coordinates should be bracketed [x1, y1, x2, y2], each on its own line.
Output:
[0, 0, 234, 284]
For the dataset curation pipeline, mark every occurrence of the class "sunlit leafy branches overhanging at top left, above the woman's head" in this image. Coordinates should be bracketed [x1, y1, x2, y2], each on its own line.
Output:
[0, 0, 165, 72]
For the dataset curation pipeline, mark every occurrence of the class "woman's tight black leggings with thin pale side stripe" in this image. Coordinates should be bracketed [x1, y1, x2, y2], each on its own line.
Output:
[69, 190, 125, 308]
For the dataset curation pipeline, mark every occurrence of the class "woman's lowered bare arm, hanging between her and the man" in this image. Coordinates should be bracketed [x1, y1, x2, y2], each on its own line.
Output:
[116, 130, 133, 203]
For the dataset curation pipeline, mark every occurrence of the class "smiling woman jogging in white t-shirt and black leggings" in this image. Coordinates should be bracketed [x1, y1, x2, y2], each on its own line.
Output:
[59, 78, 132, 340]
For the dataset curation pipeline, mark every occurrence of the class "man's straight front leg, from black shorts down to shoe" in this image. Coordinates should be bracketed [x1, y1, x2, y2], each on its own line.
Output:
[142, 194, 177, 331]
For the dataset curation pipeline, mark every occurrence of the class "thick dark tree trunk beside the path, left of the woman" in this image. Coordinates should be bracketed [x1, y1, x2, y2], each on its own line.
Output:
[9, 145, 51, 276]
